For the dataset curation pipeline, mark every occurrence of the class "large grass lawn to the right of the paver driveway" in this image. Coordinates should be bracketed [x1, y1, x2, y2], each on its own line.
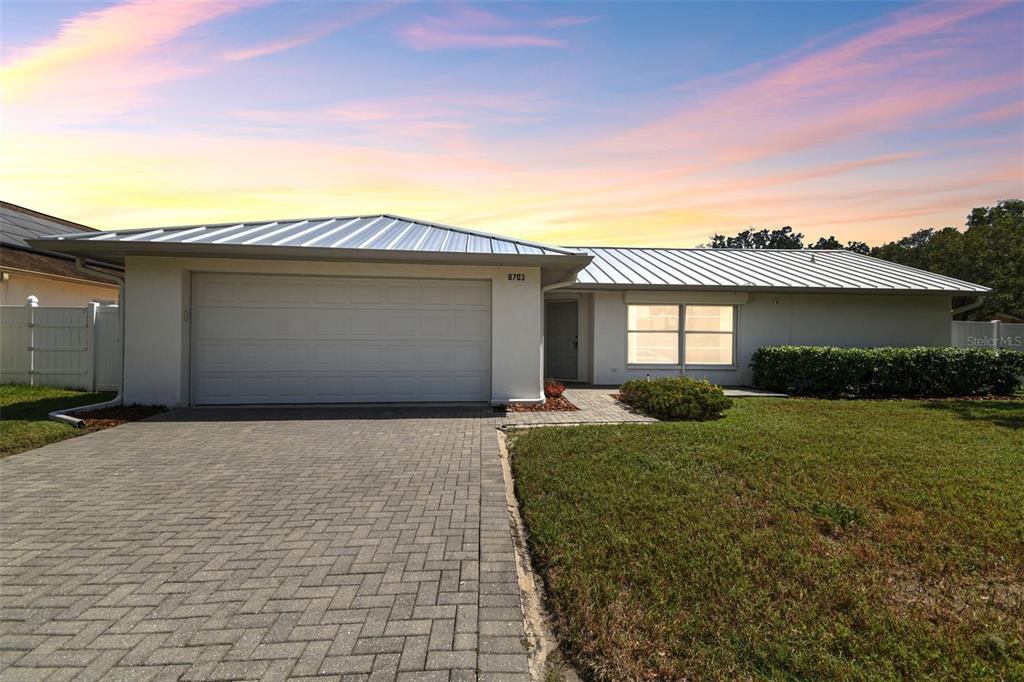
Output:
[512, 398, 1024, 680]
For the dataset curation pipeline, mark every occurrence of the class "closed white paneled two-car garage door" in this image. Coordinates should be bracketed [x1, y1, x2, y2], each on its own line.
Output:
[191, 273, 490, 404]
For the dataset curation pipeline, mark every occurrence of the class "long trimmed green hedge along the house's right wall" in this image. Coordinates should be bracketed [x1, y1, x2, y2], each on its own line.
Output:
[751, 346, 1024, 397]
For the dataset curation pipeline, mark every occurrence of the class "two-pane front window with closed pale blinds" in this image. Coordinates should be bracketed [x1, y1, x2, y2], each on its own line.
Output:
[627, 305, 735, 367]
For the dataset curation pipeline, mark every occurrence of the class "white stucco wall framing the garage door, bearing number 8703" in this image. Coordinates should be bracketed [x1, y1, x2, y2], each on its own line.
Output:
[125, 257, 543, 406]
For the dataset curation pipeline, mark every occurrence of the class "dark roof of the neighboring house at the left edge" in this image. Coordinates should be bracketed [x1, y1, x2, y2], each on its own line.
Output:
[0, 201, 120, 287]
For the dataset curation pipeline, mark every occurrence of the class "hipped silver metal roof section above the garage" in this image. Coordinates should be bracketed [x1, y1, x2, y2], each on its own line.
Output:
[48, 214, 582, 256]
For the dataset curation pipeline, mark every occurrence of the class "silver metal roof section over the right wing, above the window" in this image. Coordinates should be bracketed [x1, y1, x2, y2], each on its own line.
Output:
[574, 247, 990, 294]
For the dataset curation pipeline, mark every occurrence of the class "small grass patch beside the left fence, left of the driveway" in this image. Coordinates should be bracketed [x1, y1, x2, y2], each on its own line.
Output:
[0, 385, 115, 458]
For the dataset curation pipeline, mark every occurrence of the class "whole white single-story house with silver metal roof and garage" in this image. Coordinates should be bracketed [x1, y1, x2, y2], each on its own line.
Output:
[33, 215, 988, 406]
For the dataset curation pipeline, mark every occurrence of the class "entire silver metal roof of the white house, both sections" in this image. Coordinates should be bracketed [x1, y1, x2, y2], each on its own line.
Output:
[29, 206, 989, 294]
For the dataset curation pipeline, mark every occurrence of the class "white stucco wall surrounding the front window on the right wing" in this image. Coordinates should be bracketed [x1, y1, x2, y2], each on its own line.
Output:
[592, 291, 951, 386]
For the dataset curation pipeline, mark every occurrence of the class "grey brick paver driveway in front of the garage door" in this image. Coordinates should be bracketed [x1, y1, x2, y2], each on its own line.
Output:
[0, 408, 528, 680]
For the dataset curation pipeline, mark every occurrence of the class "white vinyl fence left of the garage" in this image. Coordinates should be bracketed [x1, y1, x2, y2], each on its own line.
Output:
[0, 296, 121, 391]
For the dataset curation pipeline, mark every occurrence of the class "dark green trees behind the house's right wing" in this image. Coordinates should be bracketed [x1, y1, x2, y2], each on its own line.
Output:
[705, 199, 1024, 322]
